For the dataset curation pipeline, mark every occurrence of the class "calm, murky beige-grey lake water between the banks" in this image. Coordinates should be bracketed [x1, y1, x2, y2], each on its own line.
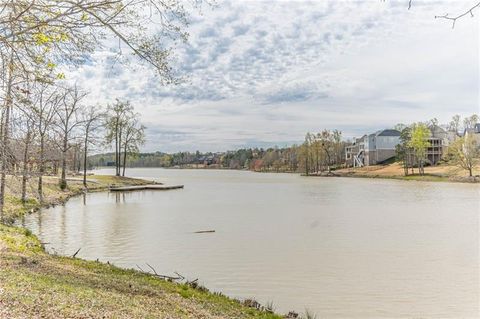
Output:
[22, 169, 480, 318]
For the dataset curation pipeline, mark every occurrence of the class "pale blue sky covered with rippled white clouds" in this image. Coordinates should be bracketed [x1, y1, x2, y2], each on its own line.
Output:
[70, 0, 480, 152]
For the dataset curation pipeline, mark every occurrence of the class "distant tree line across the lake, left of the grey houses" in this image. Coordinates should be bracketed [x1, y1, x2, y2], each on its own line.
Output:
[89, 130, 346, 174]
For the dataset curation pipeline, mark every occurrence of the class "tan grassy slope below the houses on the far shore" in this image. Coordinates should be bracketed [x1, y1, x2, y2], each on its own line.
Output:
[322, 163, 480, 183]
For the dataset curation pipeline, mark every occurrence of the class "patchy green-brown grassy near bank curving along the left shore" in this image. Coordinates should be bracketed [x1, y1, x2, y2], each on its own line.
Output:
[0, 176, 281, 318]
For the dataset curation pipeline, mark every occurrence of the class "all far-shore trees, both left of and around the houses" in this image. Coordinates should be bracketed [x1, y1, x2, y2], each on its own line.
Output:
[89, 114, 480, 180]
